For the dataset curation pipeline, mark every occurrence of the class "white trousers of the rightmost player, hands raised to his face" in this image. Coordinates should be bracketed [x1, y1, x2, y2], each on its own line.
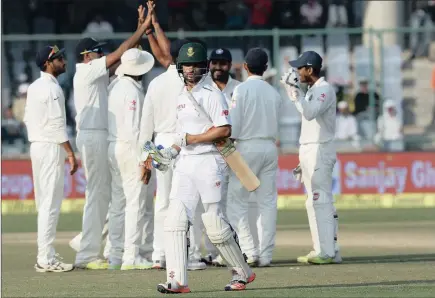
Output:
[299, 142, 338, 258]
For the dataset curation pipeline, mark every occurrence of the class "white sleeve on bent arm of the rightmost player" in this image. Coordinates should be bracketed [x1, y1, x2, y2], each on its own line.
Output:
[295, 88, 335, 121]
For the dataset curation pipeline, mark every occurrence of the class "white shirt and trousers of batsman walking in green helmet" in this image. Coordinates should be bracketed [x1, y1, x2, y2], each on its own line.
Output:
[165, 80, 231, 281]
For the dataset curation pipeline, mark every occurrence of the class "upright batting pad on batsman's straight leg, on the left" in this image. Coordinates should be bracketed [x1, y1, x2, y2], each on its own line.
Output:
[164, 200, 189, 286]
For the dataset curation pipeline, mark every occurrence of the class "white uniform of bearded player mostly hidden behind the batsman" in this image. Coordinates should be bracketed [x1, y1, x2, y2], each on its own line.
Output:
[197, 73, 240, 259]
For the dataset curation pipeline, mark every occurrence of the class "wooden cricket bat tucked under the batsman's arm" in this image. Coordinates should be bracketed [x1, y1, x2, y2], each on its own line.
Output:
[187, 92, 260, 192]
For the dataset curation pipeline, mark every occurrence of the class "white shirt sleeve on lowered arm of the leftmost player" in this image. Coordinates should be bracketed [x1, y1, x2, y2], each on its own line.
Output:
[46, 87, 68, 144]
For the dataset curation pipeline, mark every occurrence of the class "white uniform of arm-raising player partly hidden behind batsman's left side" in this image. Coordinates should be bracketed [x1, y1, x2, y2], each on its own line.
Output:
[140, 64, 184, 261]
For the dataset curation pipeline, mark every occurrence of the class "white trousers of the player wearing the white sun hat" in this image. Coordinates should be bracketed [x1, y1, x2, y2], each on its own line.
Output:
[108, 142, 149, 264]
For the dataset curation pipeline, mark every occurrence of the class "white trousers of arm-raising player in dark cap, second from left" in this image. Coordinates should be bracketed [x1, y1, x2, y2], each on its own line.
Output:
[76, 130, 111, 264]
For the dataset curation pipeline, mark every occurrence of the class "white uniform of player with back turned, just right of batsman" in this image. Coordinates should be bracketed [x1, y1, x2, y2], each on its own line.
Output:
[227, 76, 281, 263]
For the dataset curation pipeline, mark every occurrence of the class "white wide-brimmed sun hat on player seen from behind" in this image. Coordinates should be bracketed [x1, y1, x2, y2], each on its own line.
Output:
[115, 48, 154, 76]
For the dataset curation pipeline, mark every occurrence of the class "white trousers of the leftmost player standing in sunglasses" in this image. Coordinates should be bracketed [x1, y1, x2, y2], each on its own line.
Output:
[30, 142, 66, 265]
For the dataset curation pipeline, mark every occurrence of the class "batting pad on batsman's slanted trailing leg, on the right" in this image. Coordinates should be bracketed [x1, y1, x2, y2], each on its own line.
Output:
[201, 212, 252, 279]
